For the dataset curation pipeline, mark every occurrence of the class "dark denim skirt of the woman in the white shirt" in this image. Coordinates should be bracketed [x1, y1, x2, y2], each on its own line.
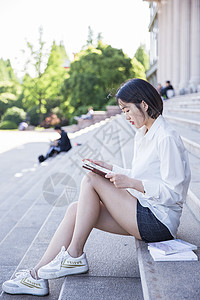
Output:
[137, 201, 173, 243]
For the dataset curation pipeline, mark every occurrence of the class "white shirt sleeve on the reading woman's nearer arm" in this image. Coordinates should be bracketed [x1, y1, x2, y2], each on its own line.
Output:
[142, 136, 185, 204]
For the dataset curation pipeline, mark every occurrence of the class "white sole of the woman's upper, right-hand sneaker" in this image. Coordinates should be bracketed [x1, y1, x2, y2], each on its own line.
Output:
[38, 266, 89, 279]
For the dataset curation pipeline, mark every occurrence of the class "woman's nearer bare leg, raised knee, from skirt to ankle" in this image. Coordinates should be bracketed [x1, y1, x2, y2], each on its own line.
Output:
[68, 172, 141, 257]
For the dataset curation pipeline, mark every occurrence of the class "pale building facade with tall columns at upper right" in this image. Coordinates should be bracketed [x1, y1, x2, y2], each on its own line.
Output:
[146, 0, 200, 94]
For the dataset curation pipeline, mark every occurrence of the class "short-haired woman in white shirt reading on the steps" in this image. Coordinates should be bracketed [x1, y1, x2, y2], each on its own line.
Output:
[2, 79, 190, 296]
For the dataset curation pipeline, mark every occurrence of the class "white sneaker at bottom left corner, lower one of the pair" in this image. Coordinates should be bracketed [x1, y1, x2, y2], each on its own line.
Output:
[2, 270, 49, 296]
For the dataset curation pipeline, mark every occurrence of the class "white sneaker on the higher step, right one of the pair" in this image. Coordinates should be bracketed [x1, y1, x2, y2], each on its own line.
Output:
[38, 246, 88, 279]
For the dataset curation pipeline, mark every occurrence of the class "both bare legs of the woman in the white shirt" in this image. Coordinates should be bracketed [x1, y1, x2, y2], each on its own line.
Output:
[35, 173, 140, 272]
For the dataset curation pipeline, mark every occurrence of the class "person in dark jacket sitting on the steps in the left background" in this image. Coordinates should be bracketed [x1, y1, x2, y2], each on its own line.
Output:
[38, 125, 72, 162]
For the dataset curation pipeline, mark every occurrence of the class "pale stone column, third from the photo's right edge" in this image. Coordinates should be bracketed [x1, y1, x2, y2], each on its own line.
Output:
[172, 0, 180, 94]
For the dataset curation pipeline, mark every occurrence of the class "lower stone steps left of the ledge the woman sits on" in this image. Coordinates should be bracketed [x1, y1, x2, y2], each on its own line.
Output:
[0, 117, 143, 300]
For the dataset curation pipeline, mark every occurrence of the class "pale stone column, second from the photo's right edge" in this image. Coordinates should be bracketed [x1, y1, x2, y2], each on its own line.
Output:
[179, 0, 193, 93]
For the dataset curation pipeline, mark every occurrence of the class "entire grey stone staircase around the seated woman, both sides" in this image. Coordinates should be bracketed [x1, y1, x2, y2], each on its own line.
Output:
[0, 94, 200, 300]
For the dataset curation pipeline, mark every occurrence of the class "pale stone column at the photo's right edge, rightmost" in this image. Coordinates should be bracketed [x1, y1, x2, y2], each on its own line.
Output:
[190, 0, 200, 92]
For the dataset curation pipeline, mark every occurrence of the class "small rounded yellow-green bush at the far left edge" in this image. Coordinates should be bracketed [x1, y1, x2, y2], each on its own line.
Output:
[2, 106, 26, 125]
